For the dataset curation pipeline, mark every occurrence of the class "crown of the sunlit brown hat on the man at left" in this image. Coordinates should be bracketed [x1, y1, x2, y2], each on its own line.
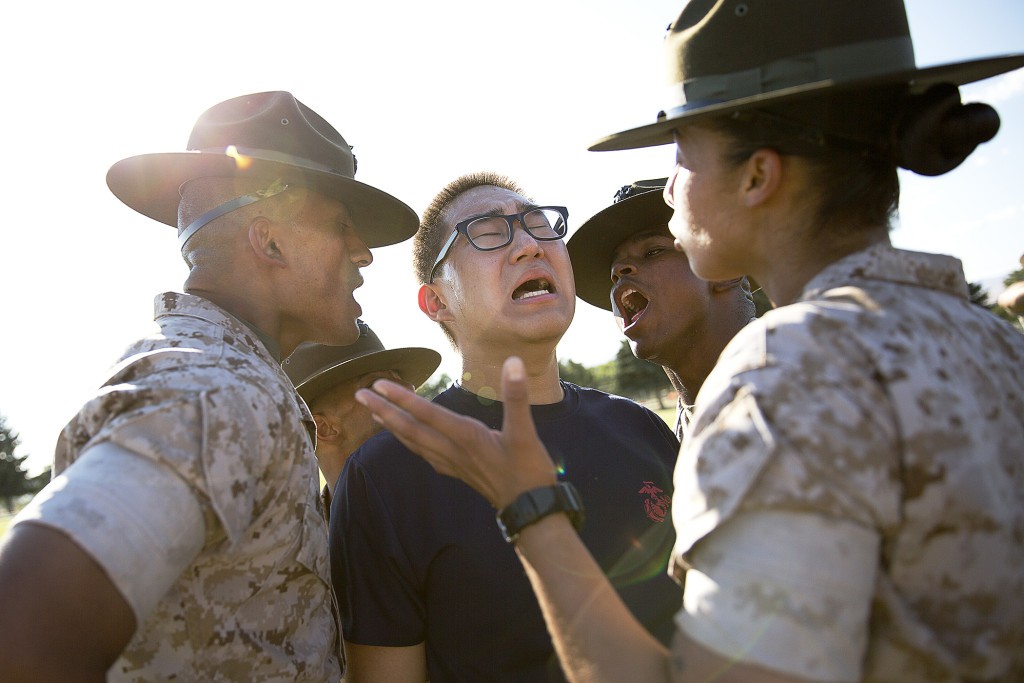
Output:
[187, 91, 355, 178]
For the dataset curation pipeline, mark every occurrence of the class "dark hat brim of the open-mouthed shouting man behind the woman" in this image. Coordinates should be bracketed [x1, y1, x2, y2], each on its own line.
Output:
[565, 190, 672, 311]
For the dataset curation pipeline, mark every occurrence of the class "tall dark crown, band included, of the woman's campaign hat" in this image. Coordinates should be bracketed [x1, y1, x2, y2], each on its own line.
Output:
[666, 0, 914, 104]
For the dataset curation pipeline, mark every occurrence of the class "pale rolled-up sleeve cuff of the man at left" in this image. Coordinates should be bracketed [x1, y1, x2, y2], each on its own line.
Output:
[15, 443, 205, 624]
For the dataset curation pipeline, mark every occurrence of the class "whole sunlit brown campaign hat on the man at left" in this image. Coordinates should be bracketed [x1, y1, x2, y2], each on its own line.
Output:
[106, 91, 419, 247]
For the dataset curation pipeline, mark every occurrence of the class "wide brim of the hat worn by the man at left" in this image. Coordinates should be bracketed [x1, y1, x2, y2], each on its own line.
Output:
[106, 152, 420, 247]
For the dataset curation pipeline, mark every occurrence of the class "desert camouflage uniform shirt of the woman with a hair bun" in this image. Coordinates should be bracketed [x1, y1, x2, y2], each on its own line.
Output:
[673, 245, 1024, 681]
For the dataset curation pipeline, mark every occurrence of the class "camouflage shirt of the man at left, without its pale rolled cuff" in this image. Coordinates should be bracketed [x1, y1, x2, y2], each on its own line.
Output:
[54, 293, 343, 682]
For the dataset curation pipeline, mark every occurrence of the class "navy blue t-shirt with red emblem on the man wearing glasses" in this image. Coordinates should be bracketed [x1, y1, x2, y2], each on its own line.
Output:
[331, 382, 682, 683]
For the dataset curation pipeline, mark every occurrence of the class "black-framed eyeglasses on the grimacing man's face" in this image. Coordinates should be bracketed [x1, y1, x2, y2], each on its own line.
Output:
[427, 206, 569, 283]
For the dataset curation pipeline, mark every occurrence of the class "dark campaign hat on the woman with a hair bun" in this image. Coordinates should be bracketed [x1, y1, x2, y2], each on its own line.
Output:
[590, 0, 1024, 152]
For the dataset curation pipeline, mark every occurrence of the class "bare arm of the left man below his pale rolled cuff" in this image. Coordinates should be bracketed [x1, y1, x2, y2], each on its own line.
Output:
[0, 523, 135, 683]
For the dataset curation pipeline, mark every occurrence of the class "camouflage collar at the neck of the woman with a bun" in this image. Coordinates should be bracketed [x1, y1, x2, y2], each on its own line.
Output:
[800, 243, 968, 301]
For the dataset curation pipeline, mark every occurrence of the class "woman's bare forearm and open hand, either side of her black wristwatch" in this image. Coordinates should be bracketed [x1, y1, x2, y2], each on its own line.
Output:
[356, 358, 795, 681]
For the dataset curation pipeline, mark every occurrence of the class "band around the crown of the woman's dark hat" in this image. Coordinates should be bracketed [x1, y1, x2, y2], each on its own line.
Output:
[659, 36, 915, 112]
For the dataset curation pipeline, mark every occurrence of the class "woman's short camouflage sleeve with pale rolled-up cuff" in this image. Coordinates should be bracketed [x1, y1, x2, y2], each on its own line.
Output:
[672, 311, 900, 670]
